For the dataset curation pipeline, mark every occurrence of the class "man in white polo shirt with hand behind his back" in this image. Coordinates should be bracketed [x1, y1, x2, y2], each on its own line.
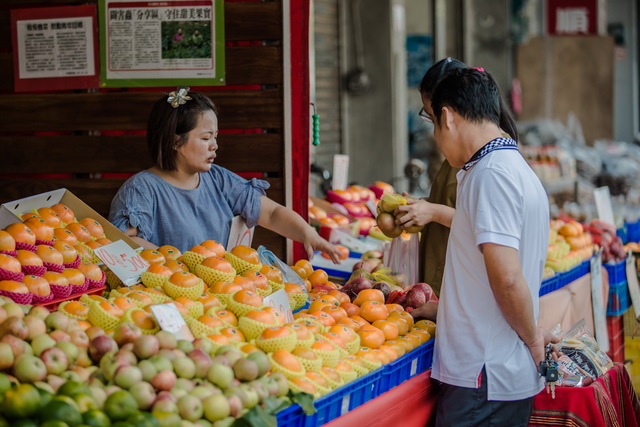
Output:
[425, 69, 555, 427]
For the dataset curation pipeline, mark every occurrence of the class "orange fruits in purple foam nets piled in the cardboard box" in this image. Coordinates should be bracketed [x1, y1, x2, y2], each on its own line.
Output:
[0, 203, 106, 304]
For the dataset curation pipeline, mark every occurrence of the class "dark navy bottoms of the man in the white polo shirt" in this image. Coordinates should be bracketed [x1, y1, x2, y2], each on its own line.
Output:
[435, 368, 533, 427]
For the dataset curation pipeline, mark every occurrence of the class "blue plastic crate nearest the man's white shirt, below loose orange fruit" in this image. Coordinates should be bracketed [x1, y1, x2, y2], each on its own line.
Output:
[378, 338, 434, 394]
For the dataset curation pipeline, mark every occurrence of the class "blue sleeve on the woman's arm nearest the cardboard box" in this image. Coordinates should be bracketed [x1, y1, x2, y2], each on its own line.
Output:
[109, 181, 153, 240]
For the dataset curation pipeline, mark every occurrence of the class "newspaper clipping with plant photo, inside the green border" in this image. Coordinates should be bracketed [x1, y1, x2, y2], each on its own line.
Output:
[105, 0, 222, 79]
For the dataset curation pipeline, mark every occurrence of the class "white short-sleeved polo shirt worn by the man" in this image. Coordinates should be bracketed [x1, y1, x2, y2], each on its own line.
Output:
[432, 150, 549, 401]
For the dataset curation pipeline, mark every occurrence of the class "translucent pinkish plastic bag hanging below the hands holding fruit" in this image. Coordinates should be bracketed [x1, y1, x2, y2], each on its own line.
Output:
[383, 233, 420, 288]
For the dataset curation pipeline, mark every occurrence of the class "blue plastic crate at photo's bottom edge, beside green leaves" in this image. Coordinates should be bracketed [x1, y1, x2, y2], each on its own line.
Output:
[277, 368, 383, 427]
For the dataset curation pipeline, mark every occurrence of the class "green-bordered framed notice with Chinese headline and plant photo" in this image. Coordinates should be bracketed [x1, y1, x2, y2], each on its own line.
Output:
[99, 0, 225, 87]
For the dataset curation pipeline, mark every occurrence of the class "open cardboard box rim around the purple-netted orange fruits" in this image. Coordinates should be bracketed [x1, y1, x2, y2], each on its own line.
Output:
[0, 188, 140, 249]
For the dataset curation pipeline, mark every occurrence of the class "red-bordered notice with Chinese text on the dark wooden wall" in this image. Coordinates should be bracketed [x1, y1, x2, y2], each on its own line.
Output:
[11, 5, 99, 92]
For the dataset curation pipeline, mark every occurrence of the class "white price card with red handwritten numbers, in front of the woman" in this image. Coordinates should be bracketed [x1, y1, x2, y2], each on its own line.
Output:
[93, 240, 149, 286]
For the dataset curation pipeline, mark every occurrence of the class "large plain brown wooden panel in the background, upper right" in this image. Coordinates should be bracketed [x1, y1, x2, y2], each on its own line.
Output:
[516, 36, 615, 144]
